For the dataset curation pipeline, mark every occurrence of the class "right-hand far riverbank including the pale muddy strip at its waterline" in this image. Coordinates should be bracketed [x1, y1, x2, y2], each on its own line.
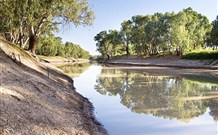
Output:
[106, 56, 218, 78]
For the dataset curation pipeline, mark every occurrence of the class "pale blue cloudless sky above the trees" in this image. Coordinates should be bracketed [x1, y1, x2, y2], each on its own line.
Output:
[56, 0, 218, 54]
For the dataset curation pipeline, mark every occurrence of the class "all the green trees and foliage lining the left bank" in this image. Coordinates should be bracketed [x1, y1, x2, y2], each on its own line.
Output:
[0, 0, 95, 58]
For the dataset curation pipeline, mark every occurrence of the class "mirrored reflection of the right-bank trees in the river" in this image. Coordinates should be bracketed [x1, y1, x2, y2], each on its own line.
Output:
[95, 68, 218, 122]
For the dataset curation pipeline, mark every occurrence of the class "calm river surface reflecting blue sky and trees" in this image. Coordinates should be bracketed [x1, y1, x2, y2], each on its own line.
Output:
[60, 64, 218, 135]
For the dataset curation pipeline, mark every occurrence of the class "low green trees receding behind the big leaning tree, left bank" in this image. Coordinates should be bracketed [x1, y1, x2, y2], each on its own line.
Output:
[36, 34, 90, 59]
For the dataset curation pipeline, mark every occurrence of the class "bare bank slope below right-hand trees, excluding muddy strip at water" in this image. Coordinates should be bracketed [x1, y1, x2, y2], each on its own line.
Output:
[104, 56, 218, 70]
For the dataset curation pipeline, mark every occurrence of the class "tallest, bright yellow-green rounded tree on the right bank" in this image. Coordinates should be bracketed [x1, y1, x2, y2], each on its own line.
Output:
[170, 8, 211, 55]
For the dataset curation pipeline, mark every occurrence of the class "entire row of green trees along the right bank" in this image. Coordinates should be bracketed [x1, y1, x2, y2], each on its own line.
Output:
[94, 8, 218, 58]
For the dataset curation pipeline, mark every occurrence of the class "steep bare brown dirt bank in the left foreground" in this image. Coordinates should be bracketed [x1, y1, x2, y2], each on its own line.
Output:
[0, 41, 106, 135]
